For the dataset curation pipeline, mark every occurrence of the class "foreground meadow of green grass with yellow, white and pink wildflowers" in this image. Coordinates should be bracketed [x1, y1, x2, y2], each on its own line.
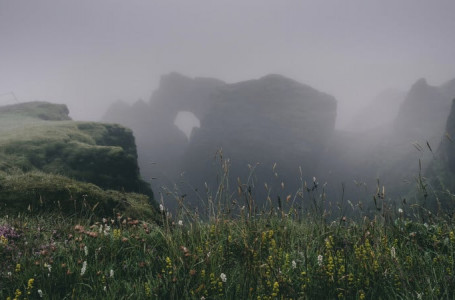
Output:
[0, 185, 455, 299]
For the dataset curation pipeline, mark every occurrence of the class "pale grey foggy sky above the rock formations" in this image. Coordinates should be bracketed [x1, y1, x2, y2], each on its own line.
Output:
[0, 0, 455, 124]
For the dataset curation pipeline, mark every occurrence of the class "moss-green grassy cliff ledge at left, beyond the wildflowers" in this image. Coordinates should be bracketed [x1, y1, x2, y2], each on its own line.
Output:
[0, 102, 157, 216]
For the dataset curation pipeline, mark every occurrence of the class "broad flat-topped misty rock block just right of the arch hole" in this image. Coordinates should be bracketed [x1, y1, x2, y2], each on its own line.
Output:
[184, 75, 336, 202]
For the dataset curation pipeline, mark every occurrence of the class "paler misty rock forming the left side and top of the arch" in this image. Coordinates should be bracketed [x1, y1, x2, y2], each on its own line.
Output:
[103, 73, 225, 187]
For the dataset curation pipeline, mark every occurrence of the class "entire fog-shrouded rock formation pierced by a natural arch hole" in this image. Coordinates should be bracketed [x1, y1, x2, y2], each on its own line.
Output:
[104, 73, 336, 209]
